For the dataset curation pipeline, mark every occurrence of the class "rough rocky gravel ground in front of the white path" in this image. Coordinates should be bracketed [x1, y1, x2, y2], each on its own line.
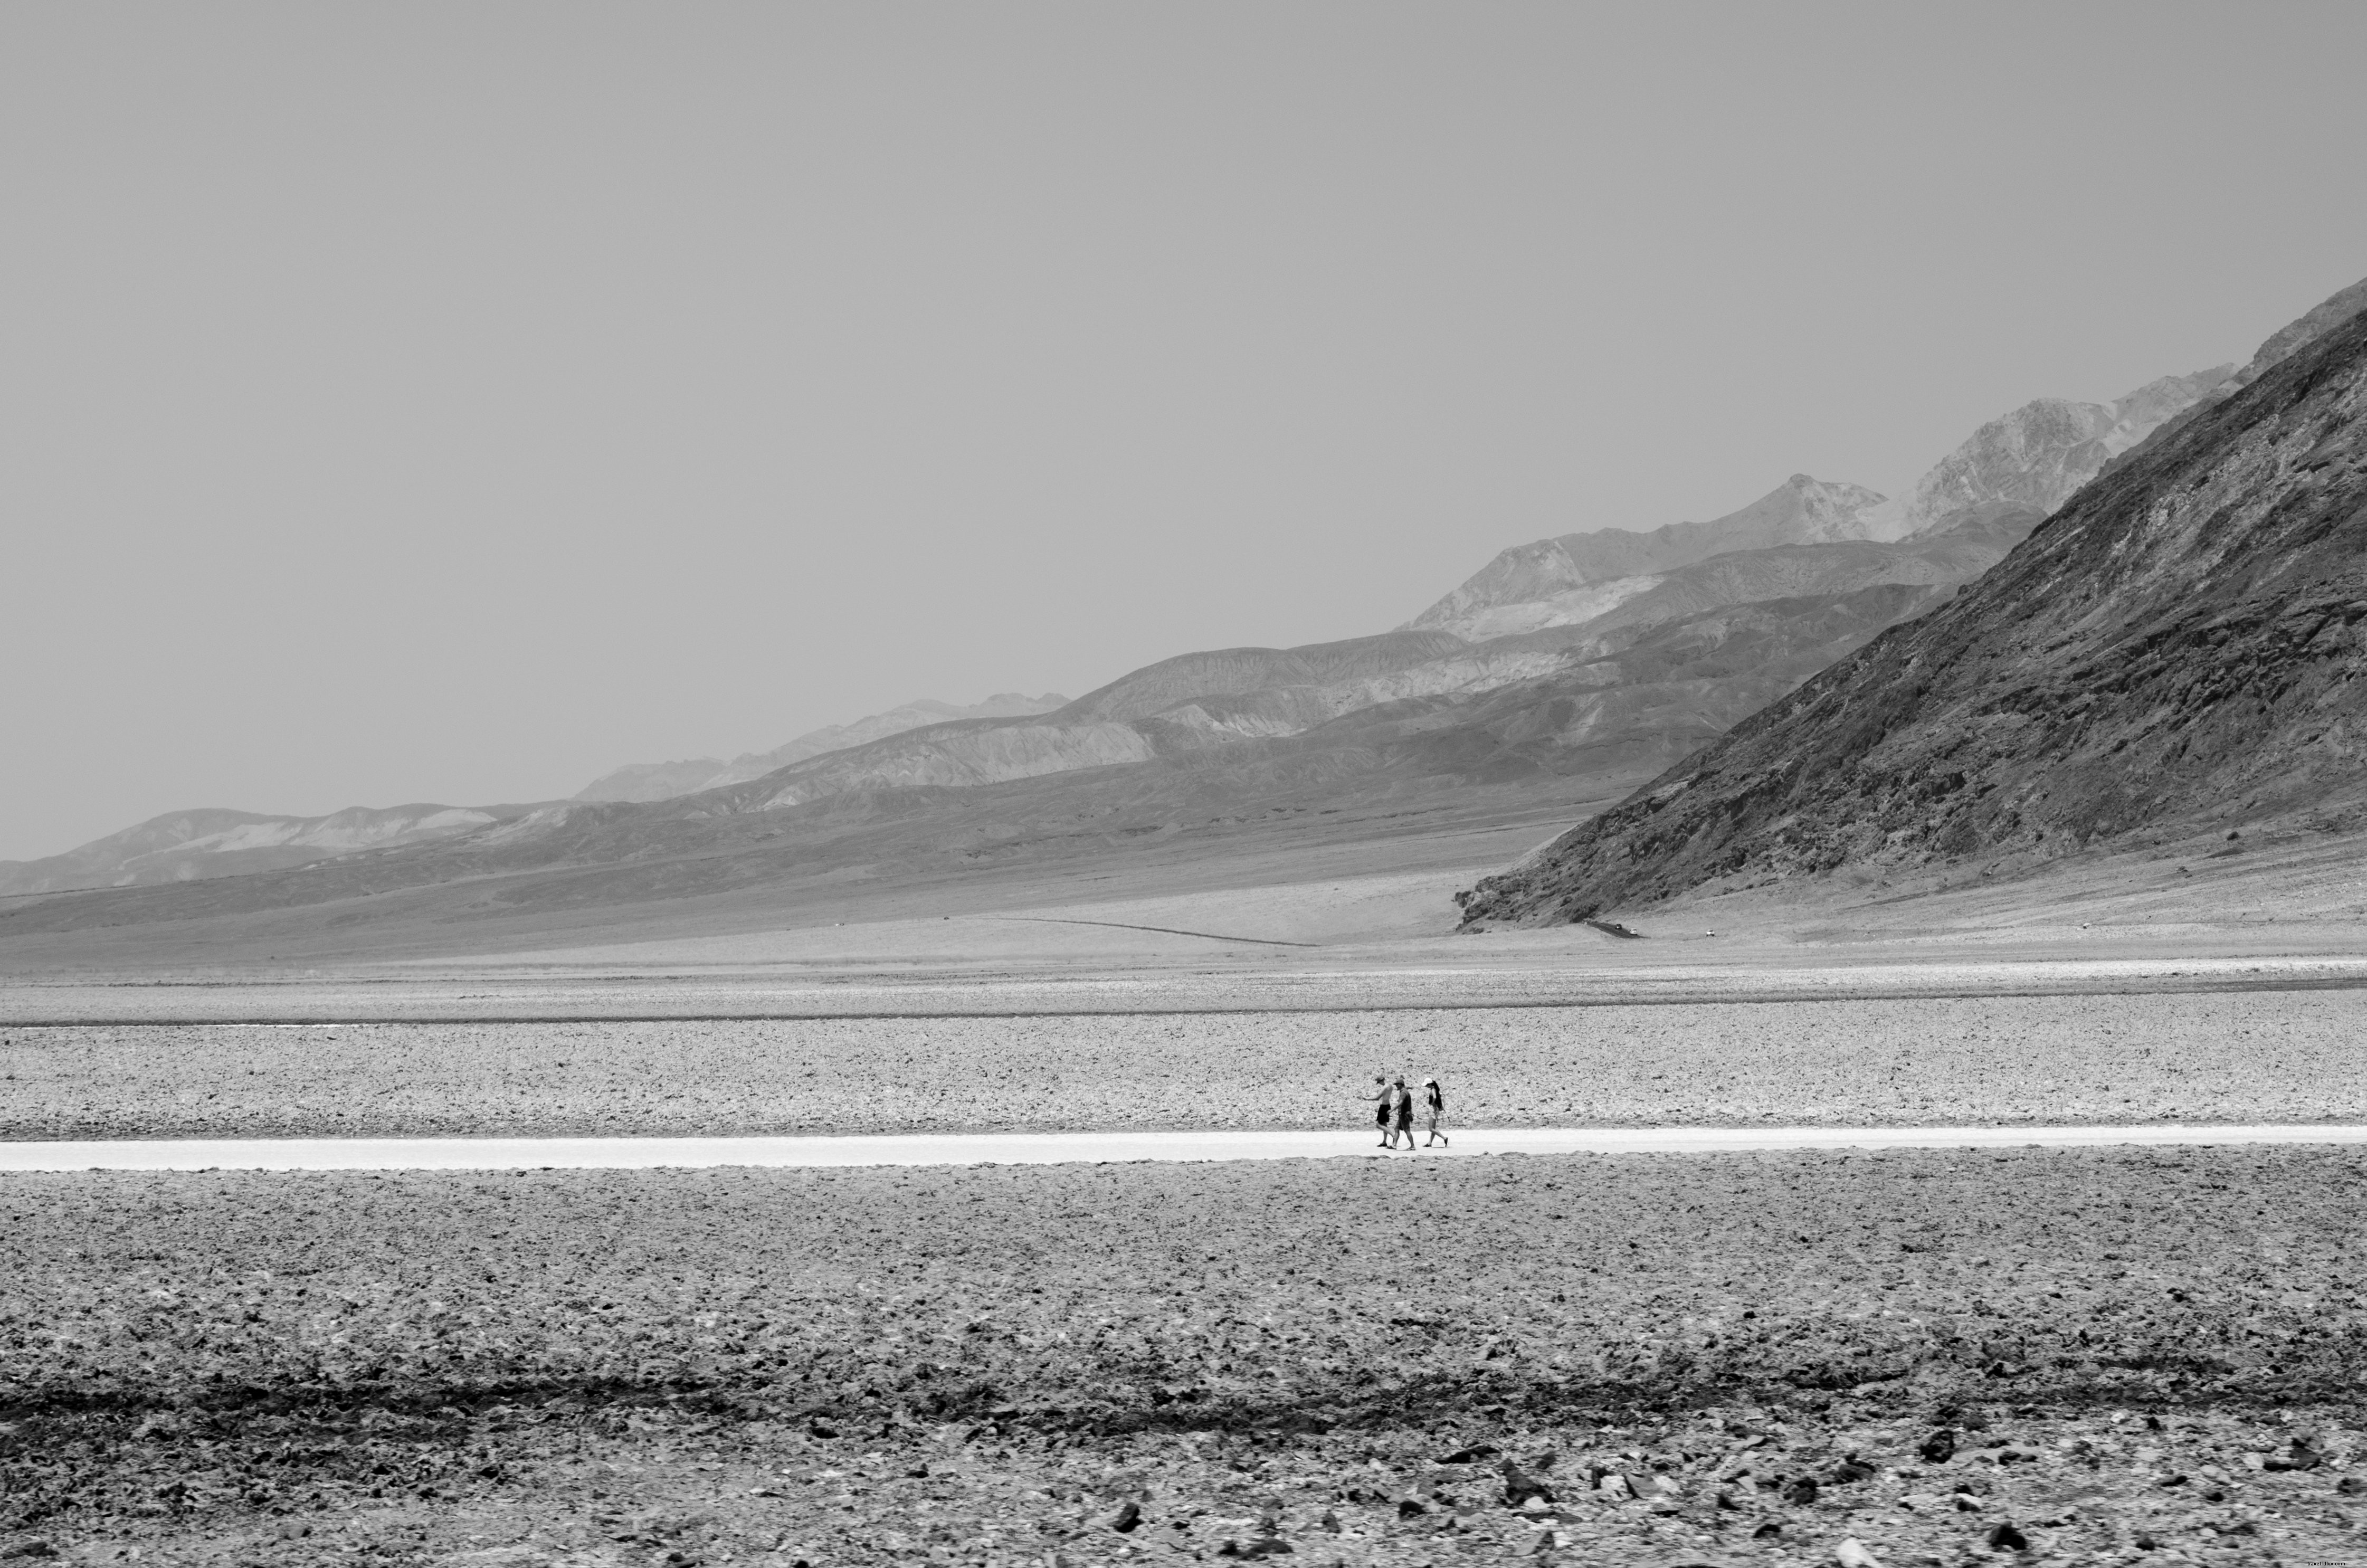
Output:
[0, 1149, 2367, 1568]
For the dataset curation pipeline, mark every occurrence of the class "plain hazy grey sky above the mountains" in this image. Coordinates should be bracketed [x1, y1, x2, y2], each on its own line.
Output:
[0, 0, 2367, 858]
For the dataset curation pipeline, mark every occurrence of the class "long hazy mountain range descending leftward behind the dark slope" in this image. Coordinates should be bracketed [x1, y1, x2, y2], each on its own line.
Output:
[0, 273, 2367, 931]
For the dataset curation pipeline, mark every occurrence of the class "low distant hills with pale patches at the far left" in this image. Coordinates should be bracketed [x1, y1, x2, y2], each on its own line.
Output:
[0, 805, 528, 895]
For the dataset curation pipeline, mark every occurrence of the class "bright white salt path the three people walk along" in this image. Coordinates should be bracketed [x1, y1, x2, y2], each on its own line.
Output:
[0, 1123, 2367, 1173]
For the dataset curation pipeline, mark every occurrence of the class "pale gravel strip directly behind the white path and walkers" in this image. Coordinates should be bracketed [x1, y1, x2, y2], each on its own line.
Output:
[0, 990, 2367, 1139]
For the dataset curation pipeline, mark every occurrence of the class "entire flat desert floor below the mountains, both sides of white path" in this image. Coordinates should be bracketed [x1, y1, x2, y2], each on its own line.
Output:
[0, 862, 2367, 1568]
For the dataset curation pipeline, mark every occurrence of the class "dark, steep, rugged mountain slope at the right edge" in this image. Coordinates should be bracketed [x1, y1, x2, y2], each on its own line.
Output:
[1460, 303, 2367, 924]
